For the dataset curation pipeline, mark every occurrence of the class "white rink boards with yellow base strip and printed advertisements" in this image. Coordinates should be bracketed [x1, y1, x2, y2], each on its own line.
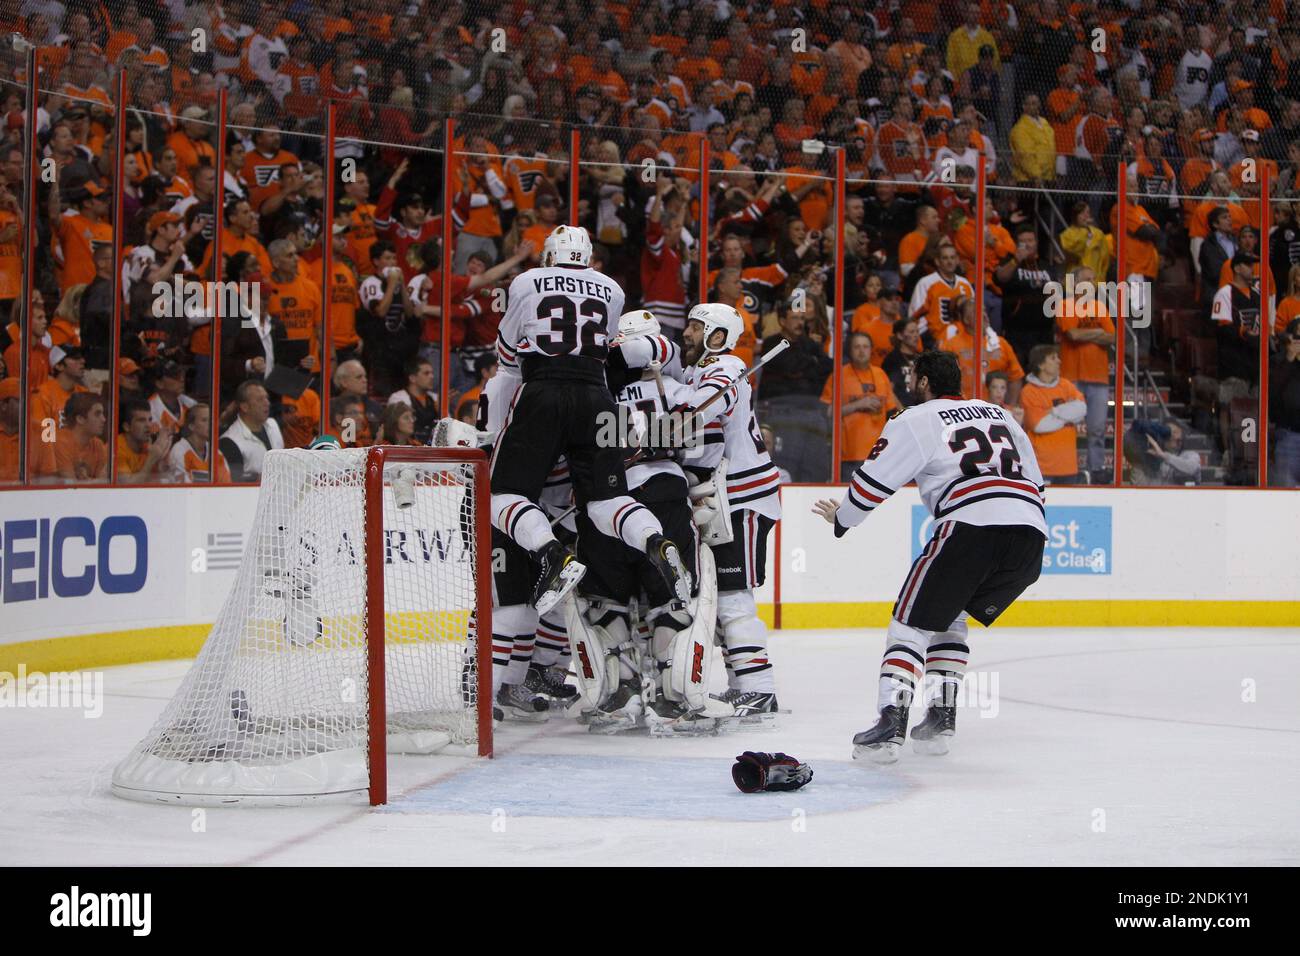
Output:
[0, 485, 1300, 672]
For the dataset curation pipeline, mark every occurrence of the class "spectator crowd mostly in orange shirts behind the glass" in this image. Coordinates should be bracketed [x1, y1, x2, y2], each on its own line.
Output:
[0, 0, 1300, 484]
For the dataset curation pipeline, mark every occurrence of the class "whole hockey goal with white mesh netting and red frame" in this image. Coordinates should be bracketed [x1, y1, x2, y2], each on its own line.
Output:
[113, 446, 491, 805]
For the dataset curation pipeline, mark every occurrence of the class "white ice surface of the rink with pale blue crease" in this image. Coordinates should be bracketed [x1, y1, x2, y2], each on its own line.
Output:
[0, 628, 1300, 866]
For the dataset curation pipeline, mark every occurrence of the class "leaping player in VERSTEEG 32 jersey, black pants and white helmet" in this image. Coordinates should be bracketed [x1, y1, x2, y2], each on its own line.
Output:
[491, 226, 690, 614]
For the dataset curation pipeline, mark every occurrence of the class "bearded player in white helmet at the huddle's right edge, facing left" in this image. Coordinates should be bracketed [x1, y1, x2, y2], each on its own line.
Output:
[614, 303, 781, 723]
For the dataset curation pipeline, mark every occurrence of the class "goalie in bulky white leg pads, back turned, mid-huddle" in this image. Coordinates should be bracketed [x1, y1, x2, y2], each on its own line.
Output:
[568, 310, 732, 736]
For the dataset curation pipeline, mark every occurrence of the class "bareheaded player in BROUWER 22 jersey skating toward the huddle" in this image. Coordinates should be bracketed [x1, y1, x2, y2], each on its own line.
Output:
[814, 351, 1047, 763]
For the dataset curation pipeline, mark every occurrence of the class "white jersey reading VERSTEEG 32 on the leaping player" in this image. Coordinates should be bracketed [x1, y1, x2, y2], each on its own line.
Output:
[497, 267, 623, 368]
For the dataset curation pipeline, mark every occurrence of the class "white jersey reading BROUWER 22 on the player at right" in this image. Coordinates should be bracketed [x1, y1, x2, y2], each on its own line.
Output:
[836, 398, 1048, 537]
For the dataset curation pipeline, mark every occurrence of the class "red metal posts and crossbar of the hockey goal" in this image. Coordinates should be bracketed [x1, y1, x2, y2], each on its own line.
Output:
[365, 445, 493, 806]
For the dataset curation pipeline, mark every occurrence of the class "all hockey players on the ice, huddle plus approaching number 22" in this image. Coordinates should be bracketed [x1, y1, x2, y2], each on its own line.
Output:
[434, 218, 1047, 762]
